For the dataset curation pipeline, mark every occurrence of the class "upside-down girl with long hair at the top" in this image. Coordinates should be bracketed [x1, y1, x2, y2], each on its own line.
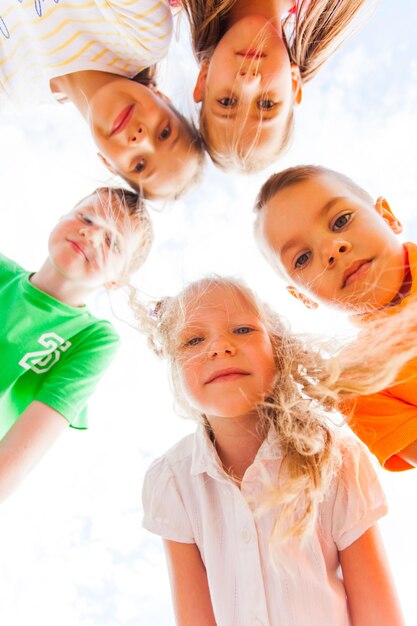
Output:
[182, 0, 365, 172]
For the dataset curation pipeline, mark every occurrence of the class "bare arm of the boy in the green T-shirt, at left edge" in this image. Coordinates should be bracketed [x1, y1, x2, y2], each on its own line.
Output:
[0, 400, 68, 502]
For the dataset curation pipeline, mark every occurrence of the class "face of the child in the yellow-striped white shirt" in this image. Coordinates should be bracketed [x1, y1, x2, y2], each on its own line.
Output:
[88, 78, 198, 198]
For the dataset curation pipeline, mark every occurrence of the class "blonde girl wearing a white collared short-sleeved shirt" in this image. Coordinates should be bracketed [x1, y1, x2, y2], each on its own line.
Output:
[143, 278, 404, 626]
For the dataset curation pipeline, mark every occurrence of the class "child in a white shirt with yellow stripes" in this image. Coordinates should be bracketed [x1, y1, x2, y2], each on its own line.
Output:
[0, 0, 203, 198]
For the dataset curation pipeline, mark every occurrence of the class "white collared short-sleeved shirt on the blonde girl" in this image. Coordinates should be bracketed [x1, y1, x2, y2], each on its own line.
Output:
[143, 426, 387, 626]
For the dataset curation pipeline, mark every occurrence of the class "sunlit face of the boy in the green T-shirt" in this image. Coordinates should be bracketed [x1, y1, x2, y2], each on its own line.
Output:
[49, 192, 133, 290]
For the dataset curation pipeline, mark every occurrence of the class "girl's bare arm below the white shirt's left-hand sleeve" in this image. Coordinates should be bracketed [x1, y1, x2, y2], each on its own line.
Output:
[164, 540, 216, 626]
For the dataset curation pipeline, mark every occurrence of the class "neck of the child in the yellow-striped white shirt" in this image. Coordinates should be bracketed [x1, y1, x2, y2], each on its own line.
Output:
[51, 70, 121, 120]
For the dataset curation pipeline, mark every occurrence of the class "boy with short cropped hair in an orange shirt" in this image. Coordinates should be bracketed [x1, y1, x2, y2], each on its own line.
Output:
[256, 166, 417, 471]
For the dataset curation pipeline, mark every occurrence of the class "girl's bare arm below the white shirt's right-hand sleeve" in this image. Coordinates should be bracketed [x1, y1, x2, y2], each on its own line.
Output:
[339, 526, 405, 626]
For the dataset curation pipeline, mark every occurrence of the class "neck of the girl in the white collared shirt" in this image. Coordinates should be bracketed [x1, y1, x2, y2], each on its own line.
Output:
[208, 413, 264, 484]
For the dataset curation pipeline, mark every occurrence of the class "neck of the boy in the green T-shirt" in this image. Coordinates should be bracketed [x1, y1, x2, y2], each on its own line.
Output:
[30, 259, 91, 307]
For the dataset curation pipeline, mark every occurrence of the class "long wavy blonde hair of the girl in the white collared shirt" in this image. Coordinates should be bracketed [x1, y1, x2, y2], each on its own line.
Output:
[143, 276, 417, 553]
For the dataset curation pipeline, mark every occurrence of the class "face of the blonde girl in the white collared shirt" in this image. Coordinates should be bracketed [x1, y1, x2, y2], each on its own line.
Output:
[177, 286, 276, 420]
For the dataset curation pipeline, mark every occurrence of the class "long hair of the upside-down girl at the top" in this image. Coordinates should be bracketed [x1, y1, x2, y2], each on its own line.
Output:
[182, 0, 370, 172]
